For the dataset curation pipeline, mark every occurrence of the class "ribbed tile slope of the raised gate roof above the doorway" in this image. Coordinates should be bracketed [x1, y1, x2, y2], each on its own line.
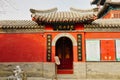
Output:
[39, 12, 95, 22]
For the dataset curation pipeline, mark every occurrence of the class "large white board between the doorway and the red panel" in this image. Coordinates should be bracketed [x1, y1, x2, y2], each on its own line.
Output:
[86, 40, 100, 61]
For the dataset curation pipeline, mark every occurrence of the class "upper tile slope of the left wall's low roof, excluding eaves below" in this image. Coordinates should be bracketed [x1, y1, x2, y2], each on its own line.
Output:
[0, 20, 40, 29]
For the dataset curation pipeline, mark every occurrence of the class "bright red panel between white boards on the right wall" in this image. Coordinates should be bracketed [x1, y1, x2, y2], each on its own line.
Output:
[101, 40, 115, 61]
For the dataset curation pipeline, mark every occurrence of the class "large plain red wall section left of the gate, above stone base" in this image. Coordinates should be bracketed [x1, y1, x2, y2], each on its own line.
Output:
[0, 34, 45, 62]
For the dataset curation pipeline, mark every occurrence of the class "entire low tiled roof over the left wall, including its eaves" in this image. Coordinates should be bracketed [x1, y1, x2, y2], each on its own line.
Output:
[0, 20, 44, 33]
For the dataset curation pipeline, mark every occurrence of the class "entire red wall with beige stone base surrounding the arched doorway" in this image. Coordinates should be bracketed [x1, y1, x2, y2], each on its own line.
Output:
[0, 27, 120, 79]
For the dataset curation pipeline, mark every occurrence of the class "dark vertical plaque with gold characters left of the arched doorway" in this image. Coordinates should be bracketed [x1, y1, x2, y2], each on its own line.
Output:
[47, 34, 52, 62]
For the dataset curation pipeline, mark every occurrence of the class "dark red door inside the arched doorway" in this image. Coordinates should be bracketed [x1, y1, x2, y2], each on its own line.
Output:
[56, 37, 73, 69]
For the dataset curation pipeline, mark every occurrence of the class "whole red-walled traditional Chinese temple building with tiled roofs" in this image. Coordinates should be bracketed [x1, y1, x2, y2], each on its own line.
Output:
[0, 0, 120, 79]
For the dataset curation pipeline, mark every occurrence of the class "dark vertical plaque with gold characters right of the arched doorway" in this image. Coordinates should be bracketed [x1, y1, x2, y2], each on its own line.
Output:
[77, 34, 82, 61]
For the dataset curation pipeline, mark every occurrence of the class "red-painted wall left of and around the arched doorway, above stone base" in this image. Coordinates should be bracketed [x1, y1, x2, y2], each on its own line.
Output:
[0, 25, 85, 62]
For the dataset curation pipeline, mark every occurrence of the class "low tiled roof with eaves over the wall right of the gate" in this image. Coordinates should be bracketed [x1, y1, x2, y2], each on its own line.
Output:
[84, 19, 120, 32]
